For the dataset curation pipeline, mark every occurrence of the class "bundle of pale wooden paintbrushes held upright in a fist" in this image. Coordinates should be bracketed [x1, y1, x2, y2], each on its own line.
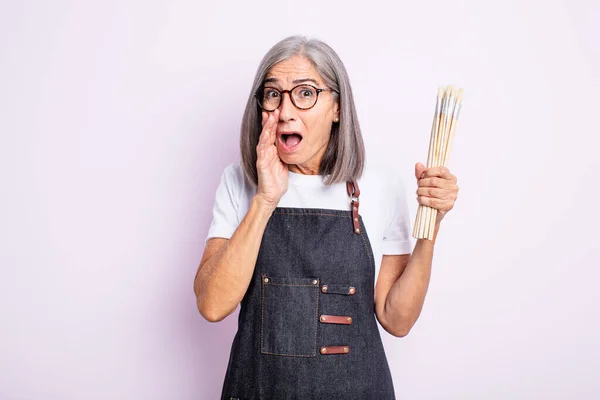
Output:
[412, 86, 463, 240]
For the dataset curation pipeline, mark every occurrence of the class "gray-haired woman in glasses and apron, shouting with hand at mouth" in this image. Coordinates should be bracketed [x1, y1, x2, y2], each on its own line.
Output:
[194, 36, 458, 400]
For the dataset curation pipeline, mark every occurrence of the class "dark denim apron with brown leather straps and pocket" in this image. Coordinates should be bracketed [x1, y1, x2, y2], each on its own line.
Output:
[221, 182, 395, 400]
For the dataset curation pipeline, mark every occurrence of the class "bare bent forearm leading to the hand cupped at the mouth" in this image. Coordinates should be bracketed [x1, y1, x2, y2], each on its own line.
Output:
[194, 197, 273, 322]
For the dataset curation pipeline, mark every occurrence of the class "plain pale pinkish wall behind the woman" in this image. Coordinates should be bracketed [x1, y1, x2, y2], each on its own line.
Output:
[0, 0, 600, 400]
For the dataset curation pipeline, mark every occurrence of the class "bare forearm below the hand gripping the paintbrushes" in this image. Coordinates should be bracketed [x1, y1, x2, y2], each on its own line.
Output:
[384, 223, 439, 336]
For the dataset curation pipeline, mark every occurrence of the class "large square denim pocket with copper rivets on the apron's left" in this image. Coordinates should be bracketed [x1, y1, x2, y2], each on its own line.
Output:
[260, 275, 319, 357]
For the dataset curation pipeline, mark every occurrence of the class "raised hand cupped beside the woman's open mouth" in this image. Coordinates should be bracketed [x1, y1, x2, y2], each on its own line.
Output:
[256, 109, 288, 209]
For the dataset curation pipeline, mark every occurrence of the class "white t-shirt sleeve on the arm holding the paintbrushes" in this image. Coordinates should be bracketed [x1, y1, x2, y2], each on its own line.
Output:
[382, 173, 413, 255]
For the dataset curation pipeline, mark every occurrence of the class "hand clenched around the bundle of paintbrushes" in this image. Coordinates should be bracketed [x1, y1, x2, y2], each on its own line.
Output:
[415, 163, 458, 223]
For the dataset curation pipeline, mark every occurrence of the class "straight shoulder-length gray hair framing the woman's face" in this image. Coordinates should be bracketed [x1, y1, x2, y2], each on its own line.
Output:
[240, 36, 366, 185]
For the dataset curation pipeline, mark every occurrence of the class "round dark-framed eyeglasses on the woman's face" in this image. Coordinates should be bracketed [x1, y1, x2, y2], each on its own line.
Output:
[254, 84, 337, 112]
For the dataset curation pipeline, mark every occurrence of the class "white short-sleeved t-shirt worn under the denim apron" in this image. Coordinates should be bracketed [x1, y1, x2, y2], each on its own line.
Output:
[206, 162, 413, 282]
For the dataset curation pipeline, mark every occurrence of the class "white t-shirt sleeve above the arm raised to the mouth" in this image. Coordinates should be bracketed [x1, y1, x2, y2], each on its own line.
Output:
[205, 164, 243, 242]
